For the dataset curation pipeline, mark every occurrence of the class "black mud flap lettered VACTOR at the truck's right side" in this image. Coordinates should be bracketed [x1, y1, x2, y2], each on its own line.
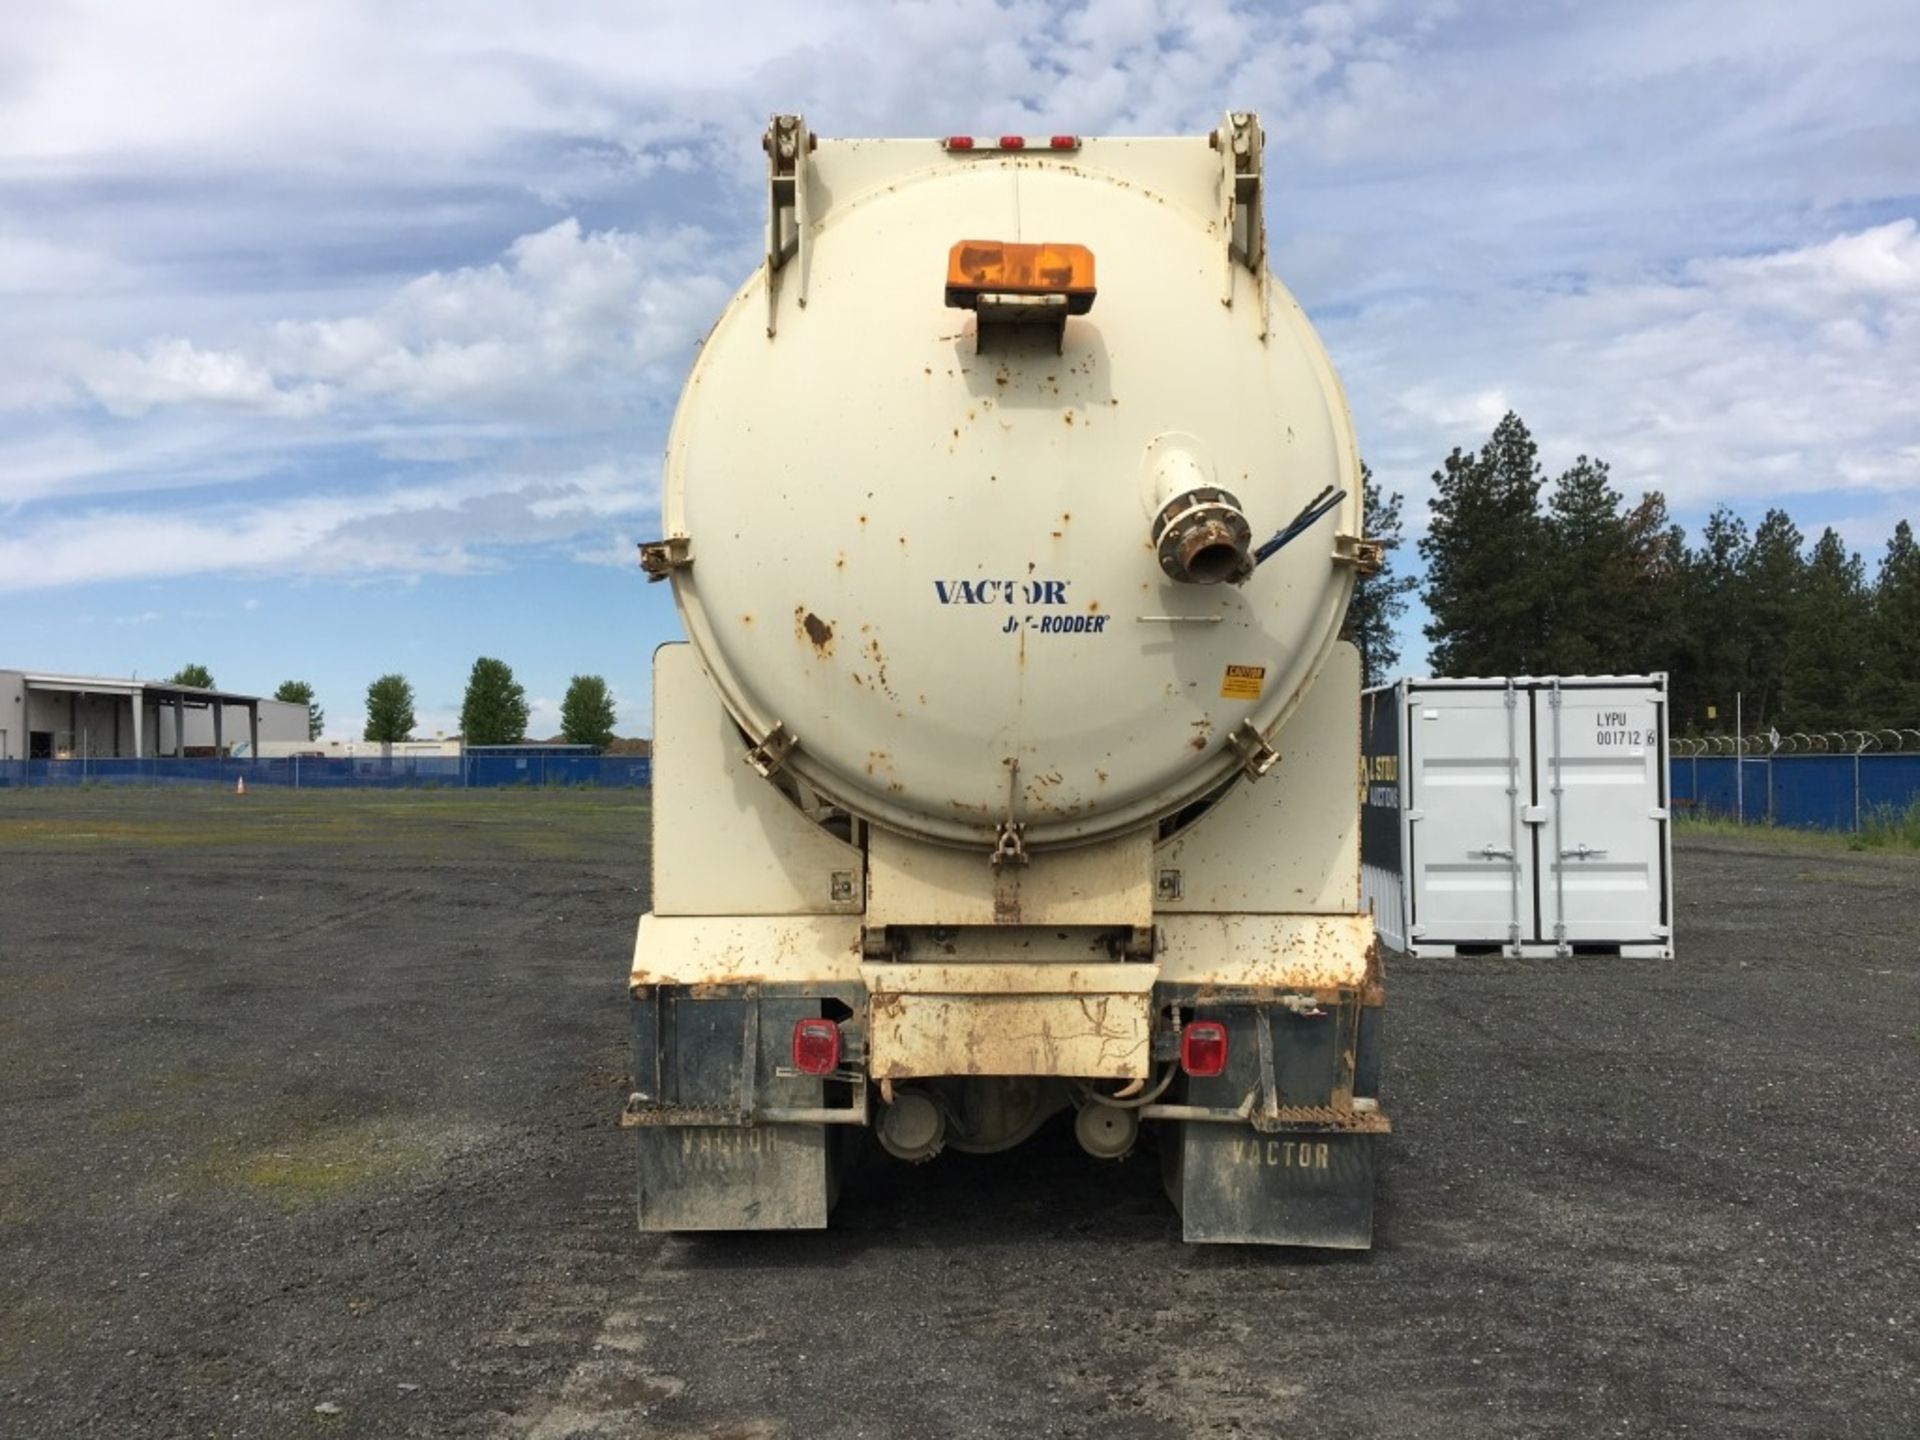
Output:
[1169, 1121, 1379, 1250]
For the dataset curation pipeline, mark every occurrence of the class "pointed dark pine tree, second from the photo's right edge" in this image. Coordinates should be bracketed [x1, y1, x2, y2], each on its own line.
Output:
[1780, 528, 1870, 730]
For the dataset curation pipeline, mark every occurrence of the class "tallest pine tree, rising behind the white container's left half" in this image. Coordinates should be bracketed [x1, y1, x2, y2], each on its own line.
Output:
[1421, 411, 1551, 676]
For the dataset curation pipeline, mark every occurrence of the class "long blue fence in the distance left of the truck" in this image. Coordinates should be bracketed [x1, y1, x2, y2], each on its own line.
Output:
[0, 755, 653, 789]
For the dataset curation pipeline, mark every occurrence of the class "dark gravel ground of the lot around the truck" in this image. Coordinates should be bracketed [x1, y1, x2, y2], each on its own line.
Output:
[0, 791, 1920, 1440]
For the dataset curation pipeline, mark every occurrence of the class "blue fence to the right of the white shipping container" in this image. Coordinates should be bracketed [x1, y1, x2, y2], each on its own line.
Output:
[1668, 755, 1920, 829]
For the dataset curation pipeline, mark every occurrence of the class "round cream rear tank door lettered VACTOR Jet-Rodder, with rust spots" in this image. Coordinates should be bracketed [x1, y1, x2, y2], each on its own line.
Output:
[664, 142, 1361, 849]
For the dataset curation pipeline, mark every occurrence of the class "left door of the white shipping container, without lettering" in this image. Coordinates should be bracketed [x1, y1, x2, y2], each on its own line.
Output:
[1402, 685, 1534, 948]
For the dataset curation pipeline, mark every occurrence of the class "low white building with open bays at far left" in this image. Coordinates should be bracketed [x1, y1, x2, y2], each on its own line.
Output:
[0, 670, 307, 760]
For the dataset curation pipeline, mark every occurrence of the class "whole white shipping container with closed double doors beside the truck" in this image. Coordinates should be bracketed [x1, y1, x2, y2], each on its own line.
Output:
[1361, 674, 1672, 958]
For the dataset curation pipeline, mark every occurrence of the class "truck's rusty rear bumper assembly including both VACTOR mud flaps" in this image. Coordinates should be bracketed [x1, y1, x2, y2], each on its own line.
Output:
[622, 918, 1392, 1248]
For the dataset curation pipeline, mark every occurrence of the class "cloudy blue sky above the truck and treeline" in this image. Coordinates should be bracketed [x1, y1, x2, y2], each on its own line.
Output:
[0, 0, 1920, 737]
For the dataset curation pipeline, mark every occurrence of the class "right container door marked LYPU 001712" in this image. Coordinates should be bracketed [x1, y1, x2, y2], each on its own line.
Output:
[1534, 682, 1672, 945]
